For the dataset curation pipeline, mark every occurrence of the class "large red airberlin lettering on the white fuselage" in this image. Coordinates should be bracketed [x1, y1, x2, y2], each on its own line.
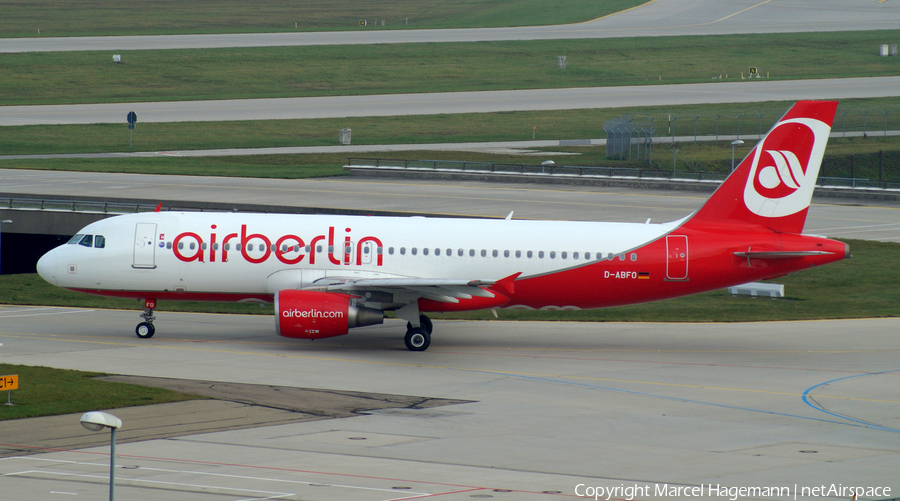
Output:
[172, 224, 384, 266]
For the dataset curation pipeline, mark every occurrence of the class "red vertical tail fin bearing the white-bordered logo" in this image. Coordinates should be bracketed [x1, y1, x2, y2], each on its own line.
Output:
[686, 101, 837, 233]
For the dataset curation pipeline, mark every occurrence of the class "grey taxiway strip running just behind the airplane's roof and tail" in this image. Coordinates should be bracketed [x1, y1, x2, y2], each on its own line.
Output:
[0, 169, 900, 242]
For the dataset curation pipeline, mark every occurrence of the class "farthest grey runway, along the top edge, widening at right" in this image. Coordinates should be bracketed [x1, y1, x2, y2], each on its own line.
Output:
[0, 0, 900, 53]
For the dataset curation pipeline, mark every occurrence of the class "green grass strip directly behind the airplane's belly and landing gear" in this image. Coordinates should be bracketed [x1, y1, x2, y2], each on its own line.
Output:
[0, 240, 900, 322]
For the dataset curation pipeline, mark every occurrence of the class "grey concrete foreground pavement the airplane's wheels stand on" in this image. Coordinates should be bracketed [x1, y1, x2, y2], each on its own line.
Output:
[0, 306, 900, 501]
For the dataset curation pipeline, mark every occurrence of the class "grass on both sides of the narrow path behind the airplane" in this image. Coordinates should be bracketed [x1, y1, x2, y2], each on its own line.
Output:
[0, 98, 900, 180]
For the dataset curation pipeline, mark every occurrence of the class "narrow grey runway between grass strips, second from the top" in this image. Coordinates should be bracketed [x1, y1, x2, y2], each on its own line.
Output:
[0, 77, 900, 126]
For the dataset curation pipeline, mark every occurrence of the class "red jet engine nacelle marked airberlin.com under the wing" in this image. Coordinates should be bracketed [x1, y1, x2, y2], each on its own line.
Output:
[275, 289, 384, 339]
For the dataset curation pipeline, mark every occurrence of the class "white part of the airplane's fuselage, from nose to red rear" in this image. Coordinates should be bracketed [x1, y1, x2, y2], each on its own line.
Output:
[39, 212, 677, 294]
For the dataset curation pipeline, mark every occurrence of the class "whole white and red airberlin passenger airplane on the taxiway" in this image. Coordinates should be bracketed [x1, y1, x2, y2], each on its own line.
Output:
[37, 101, 850, 351]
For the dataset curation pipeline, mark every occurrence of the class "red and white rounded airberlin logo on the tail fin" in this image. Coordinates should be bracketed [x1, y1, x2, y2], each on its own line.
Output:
[744, 118, 831, 217]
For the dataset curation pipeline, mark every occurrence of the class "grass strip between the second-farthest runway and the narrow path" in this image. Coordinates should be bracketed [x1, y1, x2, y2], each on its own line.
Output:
[0, 97, 900, 155]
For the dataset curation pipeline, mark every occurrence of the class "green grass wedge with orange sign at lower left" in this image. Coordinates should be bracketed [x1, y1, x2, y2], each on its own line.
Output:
[0, 363, 204, 421]
